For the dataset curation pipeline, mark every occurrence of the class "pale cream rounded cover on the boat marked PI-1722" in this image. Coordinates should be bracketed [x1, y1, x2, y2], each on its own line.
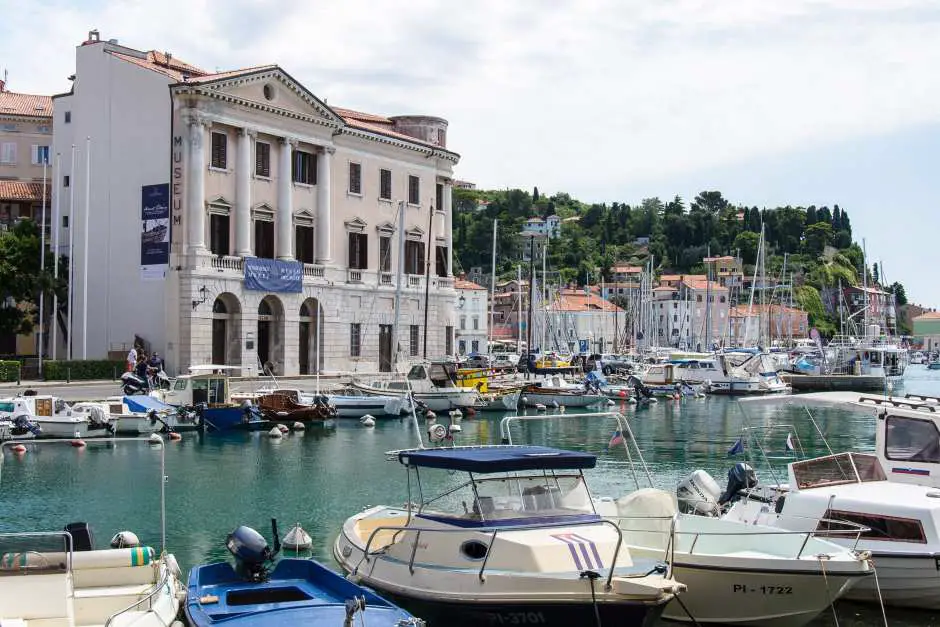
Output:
[616, 488, 678, 549]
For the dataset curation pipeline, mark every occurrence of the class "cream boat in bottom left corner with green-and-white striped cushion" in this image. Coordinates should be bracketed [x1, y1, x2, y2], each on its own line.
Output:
[0, 438, 183, 627]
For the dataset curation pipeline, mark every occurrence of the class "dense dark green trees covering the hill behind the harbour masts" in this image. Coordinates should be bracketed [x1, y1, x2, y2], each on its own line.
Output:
[454, 189, 906, 334]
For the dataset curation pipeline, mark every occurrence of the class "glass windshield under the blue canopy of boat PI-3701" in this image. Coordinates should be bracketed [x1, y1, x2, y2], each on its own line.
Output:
[422, 473, 595, 524]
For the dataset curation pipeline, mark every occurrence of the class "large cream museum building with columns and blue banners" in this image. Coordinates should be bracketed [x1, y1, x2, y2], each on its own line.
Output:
[53, 31, 459, 375]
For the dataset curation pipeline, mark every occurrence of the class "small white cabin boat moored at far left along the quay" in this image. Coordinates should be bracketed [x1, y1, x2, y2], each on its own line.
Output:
[3, 394, 114, 439]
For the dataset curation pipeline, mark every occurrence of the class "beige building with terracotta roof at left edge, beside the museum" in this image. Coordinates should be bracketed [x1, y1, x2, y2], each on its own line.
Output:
[0, 80, 52, 356]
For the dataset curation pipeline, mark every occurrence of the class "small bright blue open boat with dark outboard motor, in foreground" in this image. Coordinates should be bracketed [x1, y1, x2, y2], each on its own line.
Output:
[186, 525, 424, 627]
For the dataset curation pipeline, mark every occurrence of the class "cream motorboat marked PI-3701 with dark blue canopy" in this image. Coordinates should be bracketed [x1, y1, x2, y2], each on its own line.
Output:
[333, 446, 684, 626]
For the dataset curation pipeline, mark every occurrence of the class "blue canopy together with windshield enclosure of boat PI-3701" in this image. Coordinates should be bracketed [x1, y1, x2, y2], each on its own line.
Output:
[398, 446, 600, 527]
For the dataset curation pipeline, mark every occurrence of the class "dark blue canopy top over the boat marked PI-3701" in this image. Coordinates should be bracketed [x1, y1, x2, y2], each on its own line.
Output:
[398, 446, 597, 473]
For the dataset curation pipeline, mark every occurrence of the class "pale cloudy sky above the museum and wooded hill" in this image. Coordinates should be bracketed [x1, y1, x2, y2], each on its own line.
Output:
[0, 0, 940, 307]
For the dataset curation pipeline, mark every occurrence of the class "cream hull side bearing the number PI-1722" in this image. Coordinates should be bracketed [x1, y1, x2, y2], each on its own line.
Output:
[663, 556, 871, 627]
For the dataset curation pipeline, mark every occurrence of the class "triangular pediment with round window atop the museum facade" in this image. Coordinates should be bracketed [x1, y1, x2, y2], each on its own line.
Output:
[178, 65, 344, 126]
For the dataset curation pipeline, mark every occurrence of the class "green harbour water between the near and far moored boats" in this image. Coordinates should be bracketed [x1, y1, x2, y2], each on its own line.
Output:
[0, 366, 940, 625]
